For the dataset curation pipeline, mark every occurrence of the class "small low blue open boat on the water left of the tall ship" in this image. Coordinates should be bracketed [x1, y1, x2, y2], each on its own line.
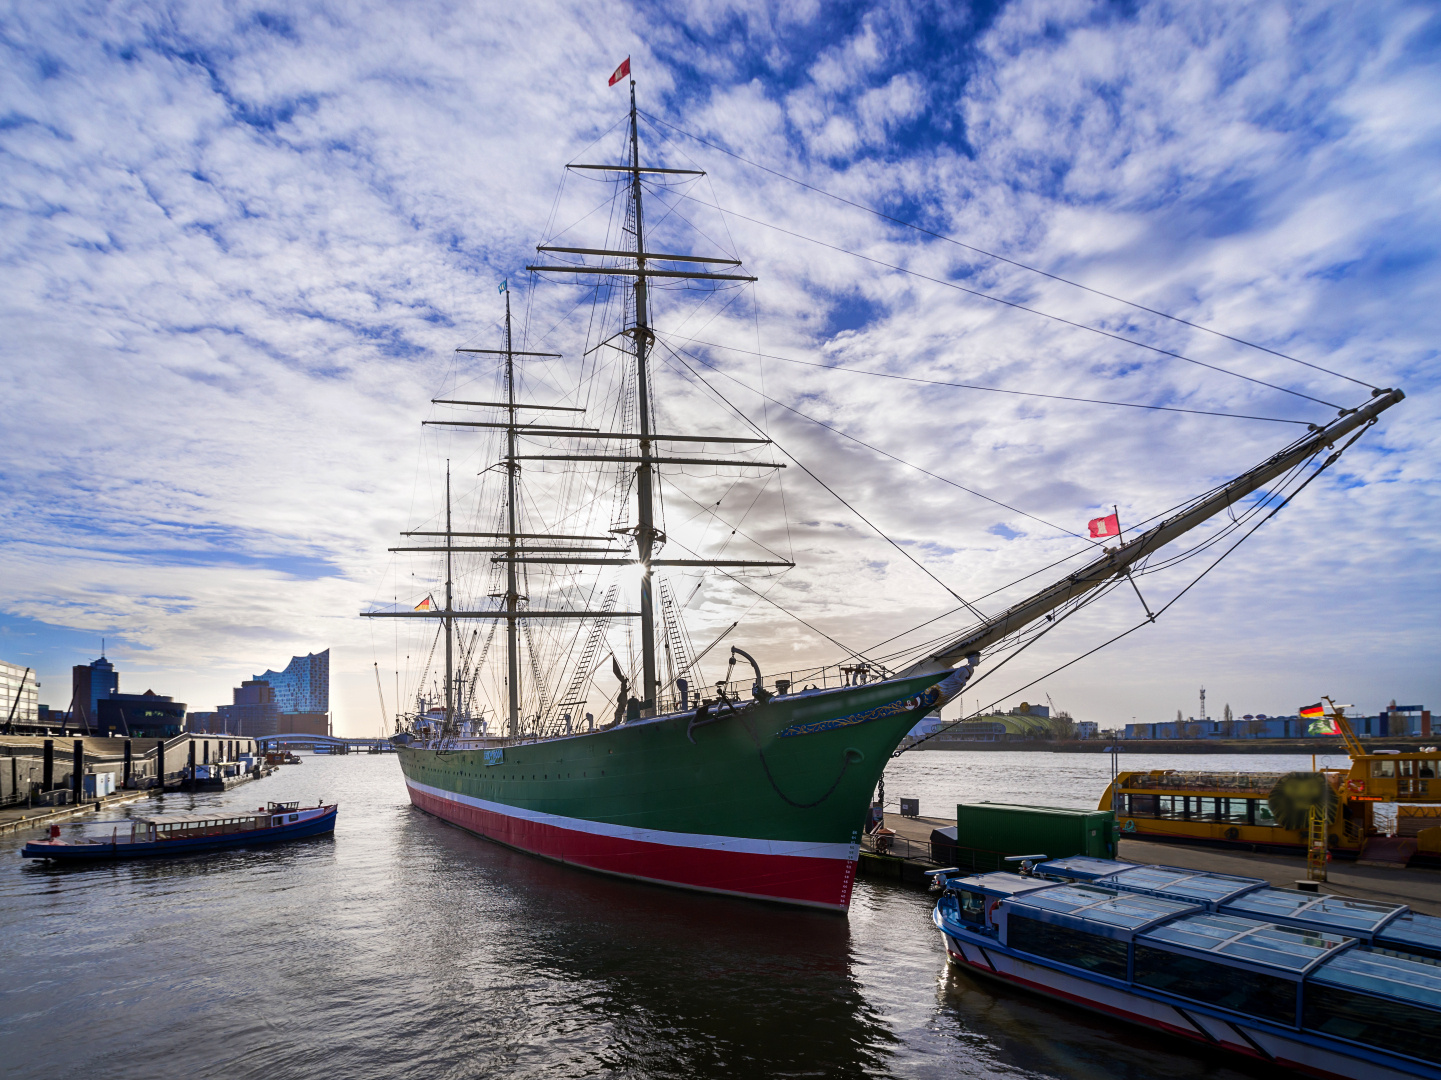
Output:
[20, 802, 340, 862]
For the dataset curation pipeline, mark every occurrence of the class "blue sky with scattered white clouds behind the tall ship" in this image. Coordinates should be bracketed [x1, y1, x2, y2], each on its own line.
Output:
[0, 0, 1441, 734]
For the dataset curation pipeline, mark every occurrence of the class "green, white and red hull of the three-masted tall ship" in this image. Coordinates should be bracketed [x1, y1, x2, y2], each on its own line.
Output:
[401, 669, 951, 911]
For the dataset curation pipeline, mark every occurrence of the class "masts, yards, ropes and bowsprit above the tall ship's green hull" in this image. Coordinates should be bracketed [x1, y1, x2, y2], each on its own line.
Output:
[366, 81, 1401, 738]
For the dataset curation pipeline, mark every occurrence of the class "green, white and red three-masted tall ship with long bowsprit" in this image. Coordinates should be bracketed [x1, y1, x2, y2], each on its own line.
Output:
[365, 73, 1404, 913]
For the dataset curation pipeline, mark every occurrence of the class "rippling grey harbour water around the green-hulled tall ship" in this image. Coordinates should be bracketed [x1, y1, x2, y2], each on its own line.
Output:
[0, 753, 1291, 1080]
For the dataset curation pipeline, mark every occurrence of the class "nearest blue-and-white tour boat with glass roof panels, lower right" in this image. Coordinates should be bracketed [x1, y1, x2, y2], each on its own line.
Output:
[932, 859, 1441, 1080]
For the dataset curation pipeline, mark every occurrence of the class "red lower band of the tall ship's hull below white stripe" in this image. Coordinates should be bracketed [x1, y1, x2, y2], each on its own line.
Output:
[406, 784, 856, 913]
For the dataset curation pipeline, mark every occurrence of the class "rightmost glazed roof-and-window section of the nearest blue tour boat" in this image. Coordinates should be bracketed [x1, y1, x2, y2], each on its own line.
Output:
[1301, 949, 1441, 1061]
